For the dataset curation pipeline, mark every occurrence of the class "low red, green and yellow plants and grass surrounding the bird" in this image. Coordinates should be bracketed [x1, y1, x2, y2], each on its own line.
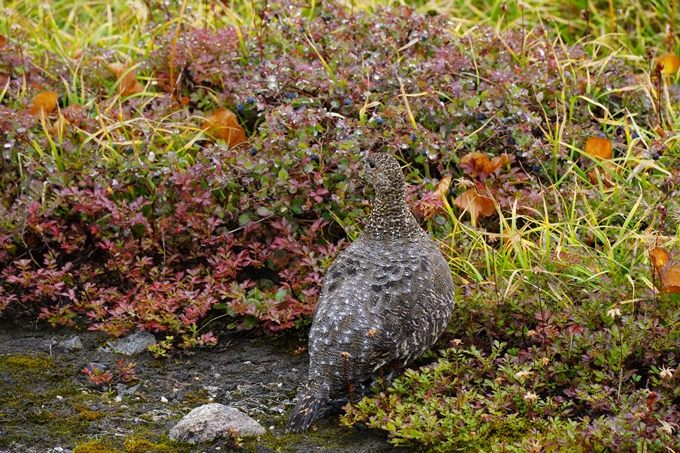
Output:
[0, 0, 680, 451]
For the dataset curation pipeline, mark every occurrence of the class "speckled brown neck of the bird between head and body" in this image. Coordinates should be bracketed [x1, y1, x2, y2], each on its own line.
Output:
[363, 192, 423, 238]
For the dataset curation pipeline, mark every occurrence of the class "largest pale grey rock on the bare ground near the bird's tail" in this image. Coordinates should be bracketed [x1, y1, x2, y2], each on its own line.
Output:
[169, 403, 266, 443]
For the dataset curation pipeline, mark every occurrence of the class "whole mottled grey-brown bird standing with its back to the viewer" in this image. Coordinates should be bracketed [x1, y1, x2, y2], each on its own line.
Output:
[287, 153, 454, 432]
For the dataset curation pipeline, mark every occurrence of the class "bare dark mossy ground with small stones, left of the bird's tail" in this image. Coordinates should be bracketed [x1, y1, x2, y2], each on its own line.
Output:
[0, 321, 409, 453]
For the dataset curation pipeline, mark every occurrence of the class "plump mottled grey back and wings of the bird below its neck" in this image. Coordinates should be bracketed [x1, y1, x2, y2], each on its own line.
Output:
[310, 238, 453, 376]
